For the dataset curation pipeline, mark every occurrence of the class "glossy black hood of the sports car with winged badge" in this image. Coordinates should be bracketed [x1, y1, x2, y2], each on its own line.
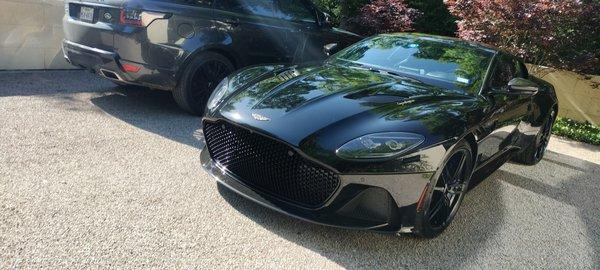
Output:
[213, 64, 475, 150]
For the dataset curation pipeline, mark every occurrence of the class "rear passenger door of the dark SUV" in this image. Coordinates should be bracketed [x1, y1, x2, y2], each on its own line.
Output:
[214, 0, 291, 65]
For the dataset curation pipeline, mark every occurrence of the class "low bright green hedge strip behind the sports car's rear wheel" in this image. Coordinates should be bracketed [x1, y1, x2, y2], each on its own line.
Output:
[552, 118, 600, 145]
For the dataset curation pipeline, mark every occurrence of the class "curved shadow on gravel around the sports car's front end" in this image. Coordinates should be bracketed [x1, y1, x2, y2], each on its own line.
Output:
[218, 160, 504, 269]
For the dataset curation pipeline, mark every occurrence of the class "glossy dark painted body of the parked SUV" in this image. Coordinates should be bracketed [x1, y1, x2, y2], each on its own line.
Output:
[63, 0, 361, 90]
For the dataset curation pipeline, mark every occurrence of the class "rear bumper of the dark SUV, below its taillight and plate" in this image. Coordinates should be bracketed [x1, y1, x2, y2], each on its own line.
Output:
[62, 40, 177, 90]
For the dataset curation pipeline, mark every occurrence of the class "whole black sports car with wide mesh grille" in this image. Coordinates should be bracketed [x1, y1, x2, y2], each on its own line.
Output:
[202, 34, 558, 237]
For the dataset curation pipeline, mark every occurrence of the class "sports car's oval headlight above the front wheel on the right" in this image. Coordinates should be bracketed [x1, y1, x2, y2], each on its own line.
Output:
[335, 132, 425, 159]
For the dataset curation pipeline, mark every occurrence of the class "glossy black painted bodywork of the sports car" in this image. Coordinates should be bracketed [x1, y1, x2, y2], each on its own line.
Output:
[202, 34, 557, 232]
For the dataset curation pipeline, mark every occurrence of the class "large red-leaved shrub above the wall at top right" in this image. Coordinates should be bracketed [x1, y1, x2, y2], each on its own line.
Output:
[445, 0, 600, 74]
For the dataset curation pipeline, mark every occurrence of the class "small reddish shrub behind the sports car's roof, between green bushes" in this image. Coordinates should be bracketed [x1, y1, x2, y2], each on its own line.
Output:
[349, 0, 421, 35]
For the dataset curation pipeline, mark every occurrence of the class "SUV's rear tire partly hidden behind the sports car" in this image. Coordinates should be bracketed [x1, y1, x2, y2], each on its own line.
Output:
[173, 52, 235, 116]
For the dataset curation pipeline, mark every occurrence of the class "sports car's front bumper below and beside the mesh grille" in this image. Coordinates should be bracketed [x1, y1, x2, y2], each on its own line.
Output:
[200, 148, 434, 233]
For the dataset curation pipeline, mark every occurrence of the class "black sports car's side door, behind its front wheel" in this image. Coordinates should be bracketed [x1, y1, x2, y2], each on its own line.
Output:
[479, 54, 531, 165]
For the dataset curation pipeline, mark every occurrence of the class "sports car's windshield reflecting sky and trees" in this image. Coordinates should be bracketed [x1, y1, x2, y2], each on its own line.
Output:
[330, 35, 494, 95]
